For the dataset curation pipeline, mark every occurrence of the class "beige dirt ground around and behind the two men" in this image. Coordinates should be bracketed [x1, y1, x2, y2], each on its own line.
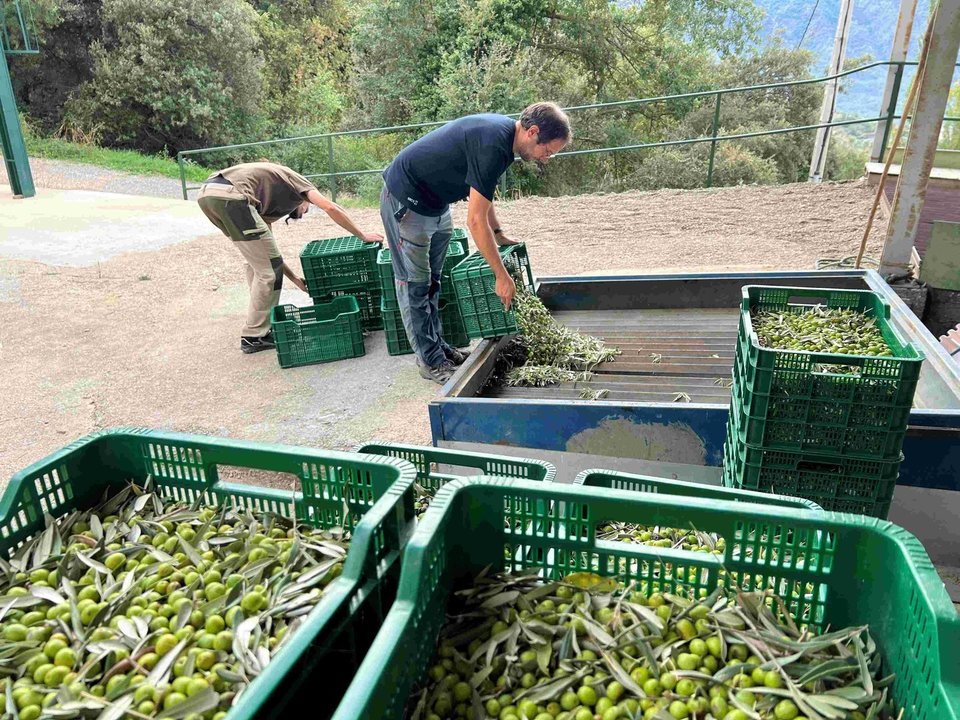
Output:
[0, 183, 883, 482]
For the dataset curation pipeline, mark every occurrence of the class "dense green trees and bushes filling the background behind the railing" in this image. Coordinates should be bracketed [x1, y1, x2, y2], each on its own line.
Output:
[12, 0, 872, 195]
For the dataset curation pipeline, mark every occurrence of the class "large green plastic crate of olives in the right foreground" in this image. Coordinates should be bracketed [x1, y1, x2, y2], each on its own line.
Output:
[334, 479, 960, 720]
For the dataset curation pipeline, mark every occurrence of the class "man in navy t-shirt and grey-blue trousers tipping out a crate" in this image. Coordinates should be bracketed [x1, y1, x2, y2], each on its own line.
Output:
[380, 102, 571, 385]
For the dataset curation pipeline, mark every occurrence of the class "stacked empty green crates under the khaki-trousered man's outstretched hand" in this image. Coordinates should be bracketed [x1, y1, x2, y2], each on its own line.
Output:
[300, 236, 383, 331]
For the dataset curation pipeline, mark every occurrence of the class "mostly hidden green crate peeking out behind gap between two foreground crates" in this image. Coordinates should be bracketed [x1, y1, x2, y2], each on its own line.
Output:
[354, 443, 557, 492]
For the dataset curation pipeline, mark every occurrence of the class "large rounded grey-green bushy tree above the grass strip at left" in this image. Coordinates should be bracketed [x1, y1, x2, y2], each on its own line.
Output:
[67, 0, 263, 152]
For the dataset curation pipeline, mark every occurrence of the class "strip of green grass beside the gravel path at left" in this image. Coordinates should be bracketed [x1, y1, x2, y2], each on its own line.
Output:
[24, 132, 215, 183]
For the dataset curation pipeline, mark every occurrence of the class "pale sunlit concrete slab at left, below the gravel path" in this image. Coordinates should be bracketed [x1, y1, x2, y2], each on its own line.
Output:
[0, 185, 212, 267]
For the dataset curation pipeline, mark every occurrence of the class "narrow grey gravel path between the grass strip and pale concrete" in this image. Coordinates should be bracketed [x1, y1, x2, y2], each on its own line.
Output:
[30, 158, 191, 199]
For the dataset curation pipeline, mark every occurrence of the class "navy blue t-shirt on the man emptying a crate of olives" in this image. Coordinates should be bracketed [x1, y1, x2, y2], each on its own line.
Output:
[383, 113, 515, 217]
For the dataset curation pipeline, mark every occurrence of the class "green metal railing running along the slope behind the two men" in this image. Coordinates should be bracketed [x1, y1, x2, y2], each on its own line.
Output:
[177, 61, 960, 201]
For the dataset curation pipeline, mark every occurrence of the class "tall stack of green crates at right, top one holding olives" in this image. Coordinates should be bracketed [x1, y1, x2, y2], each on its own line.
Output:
[724, 286, 923, 517]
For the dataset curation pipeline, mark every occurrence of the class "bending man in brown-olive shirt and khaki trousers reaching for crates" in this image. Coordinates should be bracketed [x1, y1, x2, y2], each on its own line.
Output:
[197, 162, 383, 353]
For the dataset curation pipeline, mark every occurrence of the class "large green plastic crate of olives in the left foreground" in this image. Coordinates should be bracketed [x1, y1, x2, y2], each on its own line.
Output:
[0, 428, 416, 720]
